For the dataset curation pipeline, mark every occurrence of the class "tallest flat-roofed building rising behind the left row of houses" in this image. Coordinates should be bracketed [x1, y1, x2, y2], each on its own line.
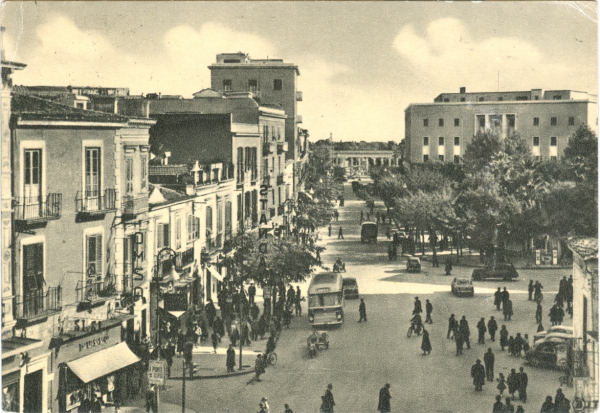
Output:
[208, 52, 302, 193]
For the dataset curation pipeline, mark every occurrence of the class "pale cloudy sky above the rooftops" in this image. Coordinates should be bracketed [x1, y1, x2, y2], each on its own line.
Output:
[0, 1, 598, 141]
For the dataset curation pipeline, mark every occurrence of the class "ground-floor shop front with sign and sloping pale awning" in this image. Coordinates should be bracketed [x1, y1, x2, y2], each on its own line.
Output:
[54, 316, 145, 412]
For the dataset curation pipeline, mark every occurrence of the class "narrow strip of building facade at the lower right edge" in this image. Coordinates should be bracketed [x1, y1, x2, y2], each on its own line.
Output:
[569, 238, 600, 411]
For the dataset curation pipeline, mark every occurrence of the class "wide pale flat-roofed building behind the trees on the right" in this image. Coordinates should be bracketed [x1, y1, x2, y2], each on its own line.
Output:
[405, 88, 597, 163]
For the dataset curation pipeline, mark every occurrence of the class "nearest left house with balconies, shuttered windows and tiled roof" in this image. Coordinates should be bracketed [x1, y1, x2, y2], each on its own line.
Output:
[9, 89, 153, 411]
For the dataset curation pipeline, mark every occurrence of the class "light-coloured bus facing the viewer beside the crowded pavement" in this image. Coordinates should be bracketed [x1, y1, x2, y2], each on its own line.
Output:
[308, 272, 344, 326]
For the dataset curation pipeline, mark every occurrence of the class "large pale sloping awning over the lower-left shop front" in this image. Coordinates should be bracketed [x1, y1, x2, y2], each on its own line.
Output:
[67, 342, 140, 383]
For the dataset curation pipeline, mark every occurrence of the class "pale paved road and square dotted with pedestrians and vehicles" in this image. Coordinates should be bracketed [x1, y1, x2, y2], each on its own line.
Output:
[162, 186, 570, 413]
